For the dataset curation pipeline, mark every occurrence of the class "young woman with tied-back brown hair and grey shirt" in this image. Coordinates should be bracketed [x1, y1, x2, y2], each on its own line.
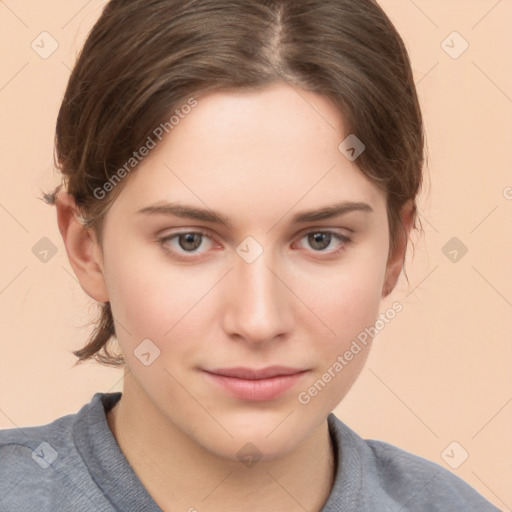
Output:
[0, 0, 497, 512]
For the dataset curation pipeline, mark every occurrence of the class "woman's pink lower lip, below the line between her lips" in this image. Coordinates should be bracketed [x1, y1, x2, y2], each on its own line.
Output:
[204, 371, 307, 402]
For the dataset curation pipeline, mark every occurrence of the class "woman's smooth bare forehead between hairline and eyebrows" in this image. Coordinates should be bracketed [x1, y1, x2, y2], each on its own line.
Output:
[109, 84, 383, 221]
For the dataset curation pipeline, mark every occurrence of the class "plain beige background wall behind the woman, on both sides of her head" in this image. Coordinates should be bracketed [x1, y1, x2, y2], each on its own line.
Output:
[0, 0, 512, 511]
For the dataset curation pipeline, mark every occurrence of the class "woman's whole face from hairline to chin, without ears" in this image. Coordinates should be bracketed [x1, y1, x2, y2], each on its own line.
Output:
[94, 84, 398, 458]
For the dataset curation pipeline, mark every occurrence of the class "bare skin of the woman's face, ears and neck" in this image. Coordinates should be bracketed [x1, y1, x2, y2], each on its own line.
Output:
[57, 83, 413, 512]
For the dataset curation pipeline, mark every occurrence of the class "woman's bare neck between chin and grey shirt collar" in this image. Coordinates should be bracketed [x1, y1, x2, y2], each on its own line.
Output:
[107, 380, 335, 512]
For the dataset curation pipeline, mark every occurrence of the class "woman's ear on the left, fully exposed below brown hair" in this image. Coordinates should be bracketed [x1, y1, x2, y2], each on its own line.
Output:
[56, 190, 109, 302]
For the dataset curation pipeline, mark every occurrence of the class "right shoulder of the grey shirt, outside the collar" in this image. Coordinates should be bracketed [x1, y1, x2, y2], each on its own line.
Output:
[330, 415, 499, 512]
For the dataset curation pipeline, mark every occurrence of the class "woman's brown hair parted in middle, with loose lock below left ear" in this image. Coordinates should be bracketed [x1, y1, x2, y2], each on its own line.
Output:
[43, 0, 424, 367]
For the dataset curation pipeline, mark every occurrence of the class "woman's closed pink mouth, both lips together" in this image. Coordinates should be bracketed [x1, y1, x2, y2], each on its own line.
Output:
[203, 366, 309, 402]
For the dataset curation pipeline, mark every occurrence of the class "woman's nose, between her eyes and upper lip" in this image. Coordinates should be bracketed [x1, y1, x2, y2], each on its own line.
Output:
[224, 246, 294, 345]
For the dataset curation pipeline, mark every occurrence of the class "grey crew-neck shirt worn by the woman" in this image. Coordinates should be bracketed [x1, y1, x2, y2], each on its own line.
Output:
[0, 392, 499, 512]
